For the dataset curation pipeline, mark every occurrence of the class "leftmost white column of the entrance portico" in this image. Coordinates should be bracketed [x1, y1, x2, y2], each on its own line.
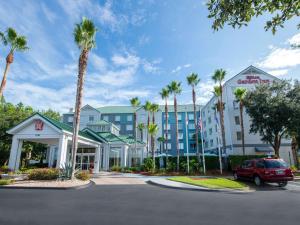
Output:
[8, 136, 23, 171]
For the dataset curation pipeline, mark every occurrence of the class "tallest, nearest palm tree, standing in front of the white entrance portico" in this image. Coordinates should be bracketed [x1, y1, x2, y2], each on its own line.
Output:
[72, 18, 97, 179]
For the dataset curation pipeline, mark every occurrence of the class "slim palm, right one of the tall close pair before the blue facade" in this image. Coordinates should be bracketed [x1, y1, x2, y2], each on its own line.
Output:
[168, 81, 182, 172]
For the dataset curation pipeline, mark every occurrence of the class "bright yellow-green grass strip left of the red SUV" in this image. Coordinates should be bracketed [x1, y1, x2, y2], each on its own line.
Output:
[168, 176, 247, 189]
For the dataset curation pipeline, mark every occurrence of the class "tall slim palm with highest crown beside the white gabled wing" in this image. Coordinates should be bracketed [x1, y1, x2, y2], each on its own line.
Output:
[212, 69, 226, 151]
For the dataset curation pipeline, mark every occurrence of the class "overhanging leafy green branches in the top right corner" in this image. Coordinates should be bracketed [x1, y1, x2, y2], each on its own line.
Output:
[207, 0, 300, 34]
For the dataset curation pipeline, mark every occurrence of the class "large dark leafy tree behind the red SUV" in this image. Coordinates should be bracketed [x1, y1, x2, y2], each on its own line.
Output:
[244, 81, 293, 157]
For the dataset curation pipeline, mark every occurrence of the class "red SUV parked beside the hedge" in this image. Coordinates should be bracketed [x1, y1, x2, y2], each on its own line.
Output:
[233, 158, 294, 187]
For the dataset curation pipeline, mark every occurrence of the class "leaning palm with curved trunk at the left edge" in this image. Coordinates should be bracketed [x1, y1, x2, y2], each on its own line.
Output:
[0, 27, 29, 99]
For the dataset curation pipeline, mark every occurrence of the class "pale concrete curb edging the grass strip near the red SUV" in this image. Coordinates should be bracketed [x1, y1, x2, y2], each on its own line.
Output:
[145, 180, 254, 194]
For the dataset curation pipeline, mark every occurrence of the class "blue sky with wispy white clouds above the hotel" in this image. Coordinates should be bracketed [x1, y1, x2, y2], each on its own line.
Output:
[0, 0, 300, 113]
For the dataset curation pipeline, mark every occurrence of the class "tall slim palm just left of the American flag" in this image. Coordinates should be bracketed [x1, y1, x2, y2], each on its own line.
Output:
[186, 73, 200, 162]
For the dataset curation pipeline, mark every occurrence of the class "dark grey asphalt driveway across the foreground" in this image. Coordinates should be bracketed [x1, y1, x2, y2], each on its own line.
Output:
[0, 178, 300, 225]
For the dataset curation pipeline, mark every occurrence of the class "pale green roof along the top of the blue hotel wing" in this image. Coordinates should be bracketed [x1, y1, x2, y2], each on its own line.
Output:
[97, 104, 201, 114]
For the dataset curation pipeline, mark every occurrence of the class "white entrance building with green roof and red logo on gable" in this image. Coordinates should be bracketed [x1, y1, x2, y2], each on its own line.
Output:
[7, 113, 145, 173]
